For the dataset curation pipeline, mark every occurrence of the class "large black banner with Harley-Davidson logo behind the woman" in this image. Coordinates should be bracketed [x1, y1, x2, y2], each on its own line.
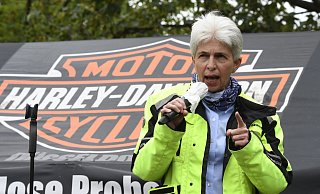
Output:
[0, 32, 320, 194]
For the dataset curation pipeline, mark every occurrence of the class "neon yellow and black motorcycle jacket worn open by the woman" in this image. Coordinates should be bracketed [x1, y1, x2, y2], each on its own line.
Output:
[132, 84, 292, 194]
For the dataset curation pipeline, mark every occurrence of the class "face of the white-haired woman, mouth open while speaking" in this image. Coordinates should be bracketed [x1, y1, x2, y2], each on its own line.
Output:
[193, 40, 241, 92]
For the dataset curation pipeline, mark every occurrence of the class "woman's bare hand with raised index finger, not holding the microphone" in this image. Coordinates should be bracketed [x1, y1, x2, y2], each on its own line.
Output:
[227, 112, 250, 148]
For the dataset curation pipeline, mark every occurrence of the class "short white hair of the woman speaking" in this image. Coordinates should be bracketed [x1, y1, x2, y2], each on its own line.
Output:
[190, 11, 243, 60]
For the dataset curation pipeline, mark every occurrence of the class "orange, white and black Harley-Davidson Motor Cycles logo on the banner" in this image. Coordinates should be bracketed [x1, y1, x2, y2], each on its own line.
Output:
[0, 39, 302, 153]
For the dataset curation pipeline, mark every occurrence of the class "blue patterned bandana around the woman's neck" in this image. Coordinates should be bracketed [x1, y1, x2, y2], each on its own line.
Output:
[192, 74, 241, 111]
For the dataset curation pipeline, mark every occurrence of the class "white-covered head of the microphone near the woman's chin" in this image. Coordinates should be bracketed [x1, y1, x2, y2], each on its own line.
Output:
[183, 82, 208, 113]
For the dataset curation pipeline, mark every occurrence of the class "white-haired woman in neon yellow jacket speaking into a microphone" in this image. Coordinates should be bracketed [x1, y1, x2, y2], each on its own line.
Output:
[132, 12, 292, 194]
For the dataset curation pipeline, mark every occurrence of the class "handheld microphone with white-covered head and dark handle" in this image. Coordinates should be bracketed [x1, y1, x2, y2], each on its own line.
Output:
[158, 82, 208, 125]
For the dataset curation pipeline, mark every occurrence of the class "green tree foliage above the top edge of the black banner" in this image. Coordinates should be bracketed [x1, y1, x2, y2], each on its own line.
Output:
[0, 0, 320, 42]
